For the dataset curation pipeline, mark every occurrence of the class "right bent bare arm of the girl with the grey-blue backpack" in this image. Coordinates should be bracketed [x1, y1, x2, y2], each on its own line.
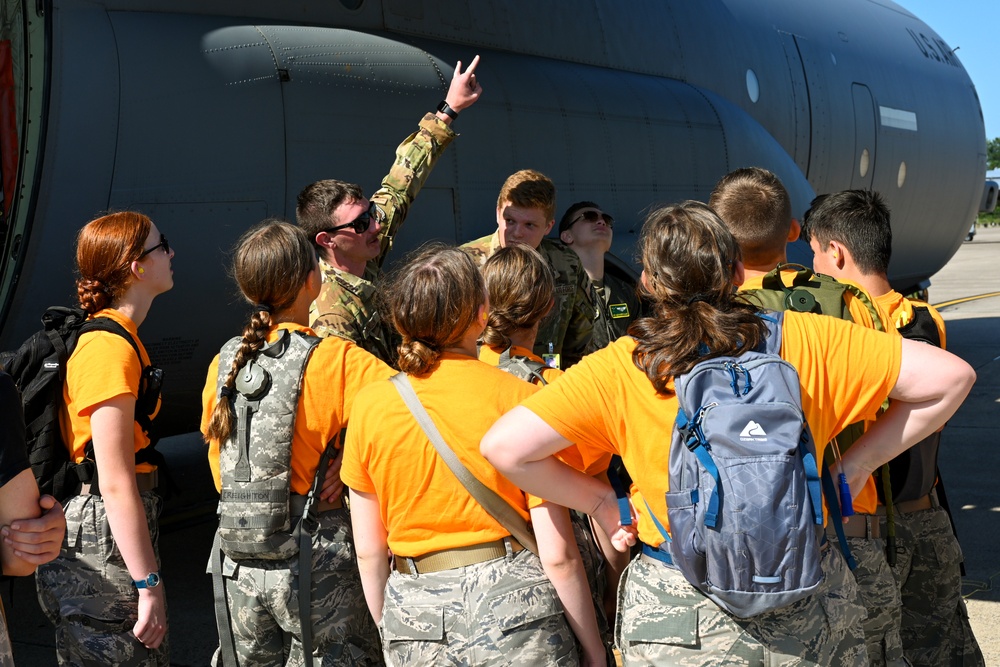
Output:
[844, 338, 976, 493]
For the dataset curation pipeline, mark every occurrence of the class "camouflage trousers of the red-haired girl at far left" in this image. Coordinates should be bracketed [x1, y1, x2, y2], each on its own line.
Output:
[35, 492, 170, 667]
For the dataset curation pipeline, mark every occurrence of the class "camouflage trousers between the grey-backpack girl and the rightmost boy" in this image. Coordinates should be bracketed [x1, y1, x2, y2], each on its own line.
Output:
[831, 537, 909, 667]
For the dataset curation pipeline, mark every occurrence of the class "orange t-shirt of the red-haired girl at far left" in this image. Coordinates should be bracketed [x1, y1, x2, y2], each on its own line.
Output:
[59, 308, 160, 472]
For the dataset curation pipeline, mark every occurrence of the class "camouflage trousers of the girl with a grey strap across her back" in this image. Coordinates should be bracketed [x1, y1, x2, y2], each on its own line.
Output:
[379, 550, 578, 667]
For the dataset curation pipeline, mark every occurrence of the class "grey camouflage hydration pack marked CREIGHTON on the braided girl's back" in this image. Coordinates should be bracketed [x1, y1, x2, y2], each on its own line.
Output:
[217, 331, 321, 560]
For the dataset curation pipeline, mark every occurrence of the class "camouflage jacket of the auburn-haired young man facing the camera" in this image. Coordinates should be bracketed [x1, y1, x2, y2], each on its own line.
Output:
[462, 232, 596, 368]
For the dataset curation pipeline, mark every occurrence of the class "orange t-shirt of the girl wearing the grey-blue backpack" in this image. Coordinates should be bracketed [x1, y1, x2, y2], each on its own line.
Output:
[523, 312, 901, 545]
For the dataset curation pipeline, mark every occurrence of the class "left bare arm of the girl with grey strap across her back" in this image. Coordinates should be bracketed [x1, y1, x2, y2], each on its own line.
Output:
[350, 489, 389, 625]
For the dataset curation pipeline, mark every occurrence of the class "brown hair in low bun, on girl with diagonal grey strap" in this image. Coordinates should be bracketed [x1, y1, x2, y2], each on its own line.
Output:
[384, 243, 486, 376]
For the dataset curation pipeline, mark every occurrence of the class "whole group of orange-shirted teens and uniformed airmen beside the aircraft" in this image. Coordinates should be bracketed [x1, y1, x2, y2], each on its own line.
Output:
[0, 57, 983, 666]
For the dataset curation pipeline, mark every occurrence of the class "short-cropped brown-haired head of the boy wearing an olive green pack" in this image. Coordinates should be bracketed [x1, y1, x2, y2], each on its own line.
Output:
[708, 167, 792, 266]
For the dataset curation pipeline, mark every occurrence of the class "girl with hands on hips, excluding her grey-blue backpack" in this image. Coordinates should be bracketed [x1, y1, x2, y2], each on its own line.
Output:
[482, 202, 975, 667]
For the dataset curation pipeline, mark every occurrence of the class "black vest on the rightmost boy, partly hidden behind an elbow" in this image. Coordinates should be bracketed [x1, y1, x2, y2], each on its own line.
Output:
[876, 306, 941, 503]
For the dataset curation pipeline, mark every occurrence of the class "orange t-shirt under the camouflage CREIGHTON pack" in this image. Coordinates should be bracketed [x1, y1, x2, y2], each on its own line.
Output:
[201, 322, 395, 495]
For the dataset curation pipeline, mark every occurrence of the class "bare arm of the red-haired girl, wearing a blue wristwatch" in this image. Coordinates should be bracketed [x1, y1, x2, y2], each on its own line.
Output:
[90, 394, 167, 648]
